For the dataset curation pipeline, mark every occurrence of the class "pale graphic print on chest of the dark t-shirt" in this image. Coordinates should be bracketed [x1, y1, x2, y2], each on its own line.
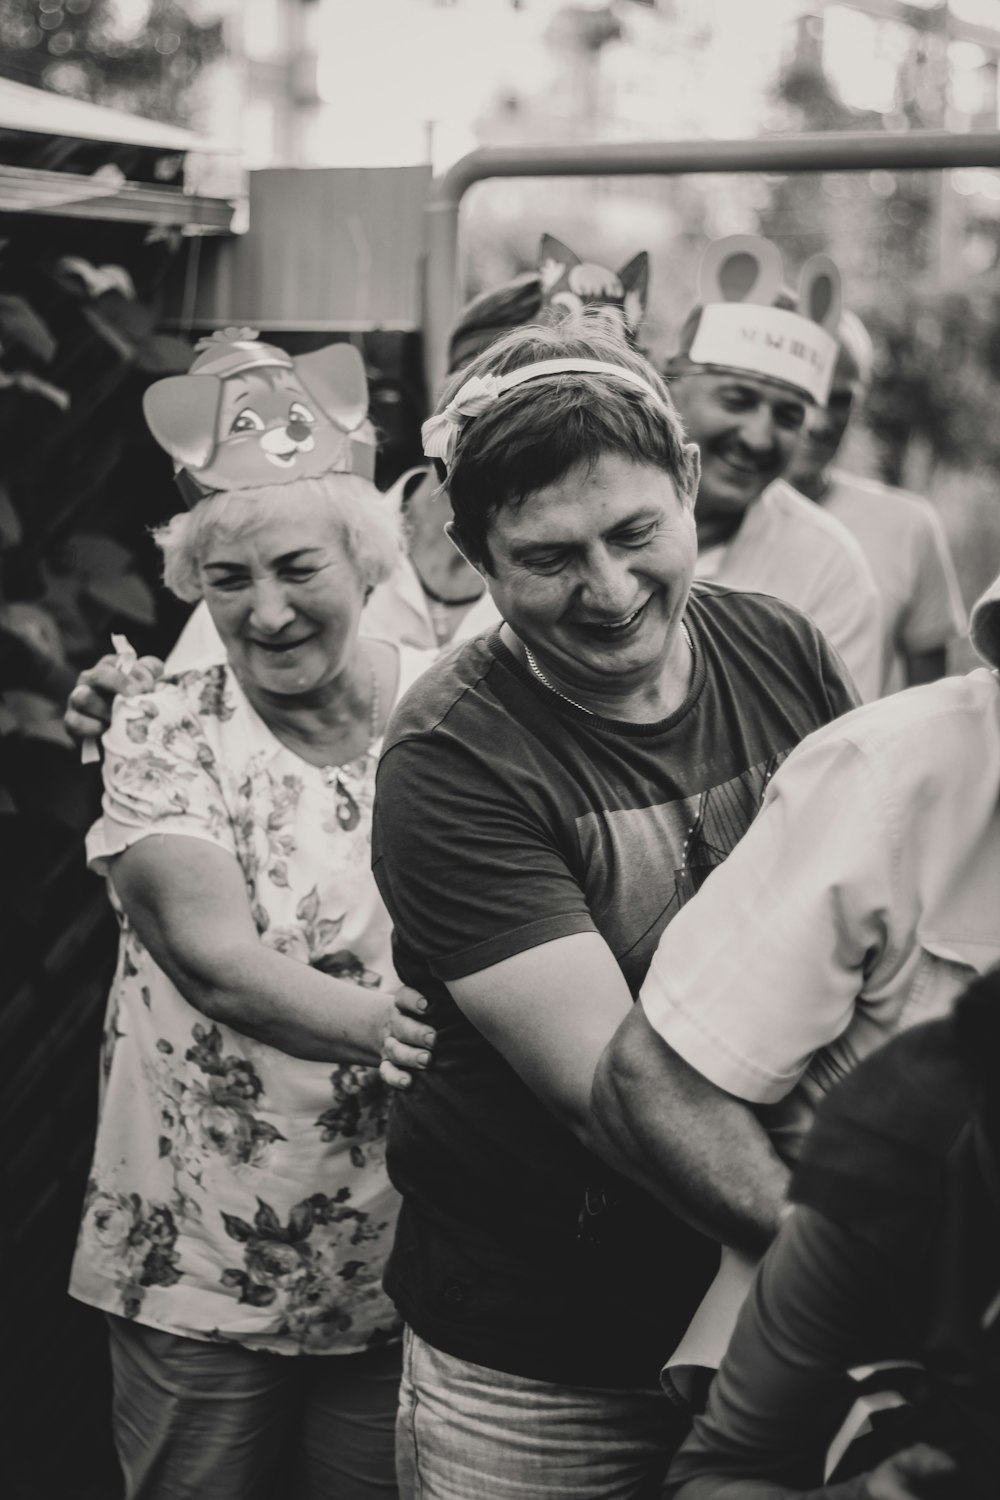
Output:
[576, 752, 787, 963]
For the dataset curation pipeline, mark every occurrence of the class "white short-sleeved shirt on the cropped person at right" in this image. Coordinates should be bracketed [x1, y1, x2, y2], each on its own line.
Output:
[640, 669, 1000, 1160]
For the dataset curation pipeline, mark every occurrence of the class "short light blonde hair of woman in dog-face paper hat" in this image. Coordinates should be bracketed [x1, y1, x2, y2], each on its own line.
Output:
[153, 474, 402, 603]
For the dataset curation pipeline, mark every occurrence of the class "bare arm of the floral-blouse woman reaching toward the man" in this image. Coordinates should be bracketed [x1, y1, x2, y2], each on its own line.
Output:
[111, 834, 413, 1067]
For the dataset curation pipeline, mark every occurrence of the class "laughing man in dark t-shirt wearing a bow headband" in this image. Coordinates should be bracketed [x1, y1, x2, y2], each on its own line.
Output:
[373, 321, 855, 1500]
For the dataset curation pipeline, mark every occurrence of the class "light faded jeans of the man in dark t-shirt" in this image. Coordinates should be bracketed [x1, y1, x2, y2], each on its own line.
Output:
[396, 1329, 685, 1500]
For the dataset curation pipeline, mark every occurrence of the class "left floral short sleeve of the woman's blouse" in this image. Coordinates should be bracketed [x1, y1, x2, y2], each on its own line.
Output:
[87, 683, 235, 875]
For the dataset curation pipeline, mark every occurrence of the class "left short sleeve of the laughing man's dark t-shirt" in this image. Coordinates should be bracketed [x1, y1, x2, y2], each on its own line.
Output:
[373, 723, 597, 981]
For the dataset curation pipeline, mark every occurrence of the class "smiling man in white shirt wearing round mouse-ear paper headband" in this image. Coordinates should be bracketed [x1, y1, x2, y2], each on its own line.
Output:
[666, 234, 882, 699]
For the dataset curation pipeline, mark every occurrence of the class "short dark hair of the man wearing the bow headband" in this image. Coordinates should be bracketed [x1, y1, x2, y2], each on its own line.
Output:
[438, 311, 696, 572]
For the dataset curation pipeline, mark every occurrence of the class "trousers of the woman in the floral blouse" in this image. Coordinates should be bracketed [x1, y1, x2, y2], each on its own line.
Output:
[106, 1314, 400, 1500]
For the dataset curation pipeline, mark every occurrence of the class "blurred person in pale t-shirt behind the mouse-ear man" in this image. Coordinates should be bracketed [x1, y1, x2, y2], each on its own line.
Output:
[786, 312, 966, 693]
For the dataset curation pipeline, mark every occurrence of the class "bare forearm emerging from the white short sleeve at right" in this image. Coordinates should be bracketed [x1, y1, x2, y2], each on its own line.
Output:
[592, 1005, 789, 1256]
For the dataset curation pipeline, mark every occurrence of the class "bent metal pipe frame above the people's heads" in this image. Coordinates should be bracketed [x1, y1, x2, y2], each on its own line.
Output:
[424, 131, 1000, 395]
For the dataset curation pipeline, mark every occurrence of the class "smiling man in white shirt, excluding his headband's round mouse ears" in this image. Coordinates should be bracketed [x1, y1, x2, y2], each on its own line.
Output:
[667, 282, 882, 701]
